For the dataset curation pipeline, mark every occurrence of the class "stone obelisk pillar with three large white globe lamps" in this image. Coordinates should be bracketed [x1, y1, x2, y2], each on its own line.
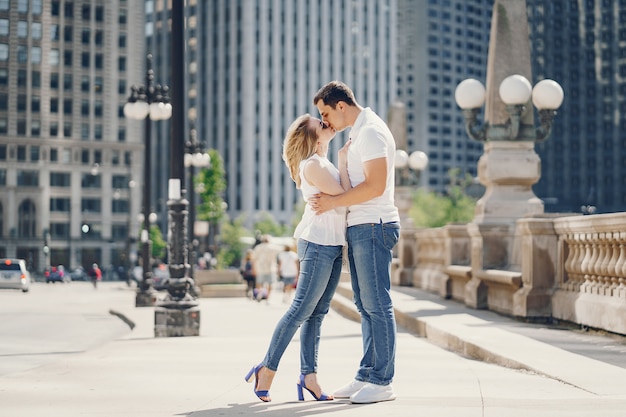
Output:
[455, 0, 563, 223]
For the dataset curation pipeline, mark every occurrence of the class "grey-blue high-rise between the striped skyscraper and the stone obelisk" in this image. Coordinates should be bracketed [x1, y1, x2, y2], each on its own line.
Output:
[396, 0, 493, 192]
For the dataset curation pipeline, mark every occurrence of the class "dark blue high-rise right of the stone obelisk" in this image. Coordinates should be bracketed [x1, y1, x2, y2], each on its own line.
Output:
[527, 0, 626, 213]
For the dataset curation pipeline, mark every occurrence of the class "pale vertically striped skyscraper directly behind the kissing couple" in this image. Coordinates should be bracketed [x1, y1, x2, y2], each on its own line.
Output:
[148, 0, 397, 227]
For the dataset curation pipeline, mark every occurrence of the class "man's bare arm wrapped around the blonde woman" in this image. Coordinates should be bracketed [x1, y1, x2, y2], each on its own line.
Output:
[310, 157, 387, 214]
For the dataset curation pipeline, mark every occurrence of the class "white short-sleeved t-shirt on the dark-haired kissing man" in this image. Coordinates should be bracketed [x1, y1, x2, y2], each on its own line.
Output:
[348, 107, 400, 226]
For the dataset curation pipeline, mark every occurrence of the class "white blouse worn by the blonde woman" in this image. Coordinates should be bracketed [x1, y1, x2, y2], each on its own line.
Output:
[293, 154, 346, 246]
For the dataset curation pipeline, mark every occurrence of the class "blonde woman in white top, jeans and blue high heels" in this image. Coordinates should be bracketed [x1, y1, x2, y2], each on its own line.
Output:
[246, 114, 348, 402]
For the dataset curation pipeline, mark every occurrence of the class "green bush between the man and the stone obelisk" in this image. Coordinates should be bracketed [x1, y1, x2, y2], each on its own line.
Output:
[409, 169, 476, 227]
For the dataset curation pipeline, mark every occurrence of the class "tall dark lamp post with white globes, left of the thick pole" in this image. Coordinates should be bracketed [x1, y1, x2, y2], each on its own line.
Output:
[124, 54, 172, 307]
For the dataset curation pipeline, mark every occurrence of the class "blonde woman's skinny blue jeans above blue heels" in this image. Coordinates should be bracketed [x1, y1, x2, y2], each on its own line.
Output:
[262, 239, 342, 375]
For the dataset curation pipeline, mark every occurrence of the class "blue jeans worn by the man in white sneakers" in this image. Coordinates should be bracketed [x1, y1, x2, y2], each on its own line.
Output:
[346, 222, 400, 385]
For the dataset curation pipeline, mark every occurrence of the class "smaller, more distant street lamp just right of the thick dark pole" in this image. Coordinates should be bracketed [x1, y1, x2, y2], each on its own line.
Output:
[185, 129, 211, 279]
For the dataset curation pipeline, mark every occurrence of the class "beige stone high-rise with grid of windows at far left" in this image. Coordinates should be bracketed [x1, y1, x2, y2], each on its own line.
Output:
[0, 0, 144, 271]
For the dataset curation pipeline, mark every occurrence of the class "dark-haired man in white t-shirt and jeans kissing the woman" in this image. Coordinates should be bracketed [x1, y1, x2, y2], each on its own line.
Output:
[310, 81, 400, 404]
